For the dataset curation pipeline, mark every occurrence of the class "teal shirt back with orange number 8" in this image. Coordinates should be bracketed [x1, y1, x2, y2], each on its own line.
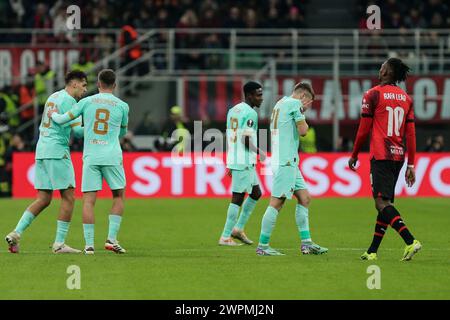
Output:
[80, 93, 129, 165]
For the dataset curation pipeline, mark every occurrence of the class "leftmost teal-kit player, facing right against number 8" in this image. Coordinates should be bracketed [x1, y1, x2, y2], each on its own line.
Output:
[5, 70, 87, 253]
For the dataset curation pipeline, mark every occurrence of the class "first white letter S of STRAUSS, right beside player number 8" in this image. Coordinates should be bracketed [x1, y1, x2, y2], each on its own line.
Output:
[131, 156, 161, 196]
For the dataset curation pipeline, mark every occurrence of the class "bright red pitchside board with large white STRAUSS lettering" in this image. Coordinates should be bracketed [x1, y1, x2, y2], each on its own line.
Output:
[13, 153, 450, 198]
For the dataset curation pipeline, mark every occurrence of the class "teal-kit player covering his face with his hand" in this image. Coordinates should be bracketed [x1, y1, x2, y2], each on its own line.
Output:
[256, 83, 328, 256]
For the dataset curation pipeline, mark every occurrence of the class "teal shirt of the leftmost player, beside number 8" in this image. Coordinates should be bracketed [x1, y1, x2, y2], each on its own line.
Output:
[36, 89, 76, 159]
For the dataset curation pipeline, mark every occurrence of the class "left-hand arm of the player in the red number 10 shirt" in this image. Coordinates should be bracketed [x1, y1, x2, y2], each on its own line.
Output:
[348, 91, 378, 170]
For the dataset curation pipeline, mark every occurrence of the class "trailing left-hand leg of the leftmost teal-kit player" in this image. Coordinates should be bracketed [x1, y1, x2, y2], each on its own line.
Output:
[5, 190, 53, 253]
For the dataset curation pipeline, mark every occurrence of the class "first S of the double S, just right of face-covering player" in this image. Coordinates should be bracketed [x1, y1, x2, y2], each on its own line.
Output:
[301, 156, 330, 196]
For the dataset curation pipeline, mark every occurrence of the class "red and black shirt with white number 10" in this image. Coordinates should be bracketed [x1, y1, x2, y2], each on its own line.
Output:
[362, 85, 414, 161]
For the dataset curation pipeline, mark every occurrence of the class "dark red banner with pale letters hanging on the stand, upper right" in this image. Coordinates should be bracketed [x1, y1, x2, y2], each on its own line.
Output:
[184, 76, 450, 124]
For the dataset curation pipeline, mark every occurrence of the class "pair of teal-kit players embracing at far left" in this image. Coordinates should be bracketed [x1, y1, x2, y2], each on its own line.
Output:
[6, 69, 128, 254]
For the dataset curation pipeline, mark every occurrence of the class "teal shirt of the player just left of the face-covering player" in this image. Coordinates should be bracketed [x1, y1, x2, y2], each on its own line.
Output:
[226, 102, 258, 170]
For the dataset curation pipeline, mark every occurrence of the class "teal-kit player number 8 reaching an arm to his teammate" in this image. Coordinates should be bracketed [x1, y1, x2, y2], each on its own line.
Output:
[49, 69, 129, 254]
